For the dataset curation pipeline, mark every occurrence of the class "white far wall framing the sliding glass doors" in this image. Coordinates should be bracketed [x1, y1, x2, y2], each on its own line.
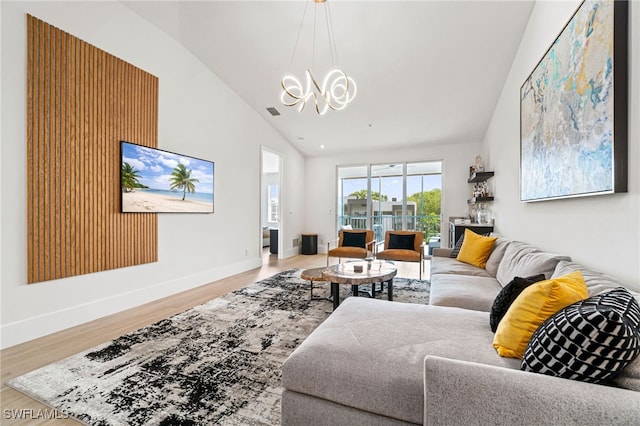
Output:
[305, 141, 481, 253]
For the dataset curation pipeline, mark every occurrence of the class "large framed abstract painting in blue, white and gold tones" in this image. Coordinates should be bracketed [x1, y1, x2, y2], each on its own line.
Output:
[520, 0, 628, 201]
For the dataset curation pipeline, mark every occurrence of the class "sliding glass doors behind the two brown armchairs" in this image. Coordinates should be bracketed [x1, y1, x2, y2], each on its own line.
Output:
[337, 161, 442, 241]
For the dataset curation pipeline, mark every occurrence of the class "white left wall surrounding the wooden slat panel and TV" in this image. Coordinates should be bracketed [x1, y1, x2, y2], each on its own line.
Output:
[0, 1, 304, 347]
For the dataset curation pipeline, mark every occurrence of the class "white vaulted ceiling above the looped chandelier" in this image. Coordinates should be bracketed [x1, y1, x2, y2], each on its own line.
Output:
[123, 0, 534, 156]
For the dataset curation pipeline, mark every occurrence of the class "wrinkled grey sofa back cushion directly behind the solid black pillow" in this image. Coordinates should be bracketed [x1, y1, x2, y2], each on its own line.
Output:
[496, 241, 571, 286]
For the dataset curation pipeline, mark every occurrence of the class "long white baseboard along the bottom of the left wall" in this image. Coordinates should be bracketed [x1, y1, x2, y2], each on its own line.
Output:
[0, 259, 261, 349]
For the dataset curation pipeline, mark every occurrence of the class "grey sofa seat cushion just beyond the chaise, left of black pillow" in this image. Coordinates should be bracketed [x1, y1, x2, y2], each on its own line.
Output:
[429, 274, 502, 312]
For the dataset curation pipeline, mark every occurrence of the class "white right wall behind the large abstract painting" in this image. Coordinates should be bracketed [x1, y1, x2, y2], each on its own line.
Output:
[483, 0, 640, 289]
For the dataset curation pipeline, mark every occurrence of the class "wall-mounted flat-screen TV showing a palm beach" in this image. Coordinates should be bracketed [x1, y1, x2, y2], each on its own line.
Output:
[120, 141, 214, 213]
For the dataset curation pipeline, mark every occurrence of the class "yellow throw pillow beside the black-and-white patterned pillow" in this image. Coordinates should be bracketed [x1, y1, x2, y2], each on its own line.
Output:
[493, 271, 589, 358]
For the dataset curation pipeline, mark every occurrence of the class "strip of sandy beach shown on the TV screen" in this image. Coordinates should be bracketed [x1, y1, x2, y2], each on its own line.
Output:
[122, 190, 213, 213]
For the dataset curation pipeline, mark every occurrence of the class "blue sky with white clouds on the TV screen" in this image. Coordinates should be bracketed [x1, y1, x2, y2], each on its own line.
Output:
[122, 142, 214, 194]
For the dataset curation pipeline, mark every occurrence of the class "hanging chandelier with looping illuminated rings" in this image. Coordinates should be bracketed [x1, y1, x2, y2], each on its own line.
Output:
[280, 0, 357, 115]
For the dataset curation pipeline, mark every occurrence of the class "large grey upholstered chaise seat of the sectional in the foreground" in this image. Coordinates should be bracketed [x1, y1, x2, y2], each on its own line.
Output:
[282, 297, 520, 424]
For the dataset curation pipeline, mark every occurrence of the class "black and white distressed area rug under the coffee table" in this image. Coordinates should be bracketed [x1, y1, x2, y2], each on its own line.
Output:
[8, 270, 429, 425]
